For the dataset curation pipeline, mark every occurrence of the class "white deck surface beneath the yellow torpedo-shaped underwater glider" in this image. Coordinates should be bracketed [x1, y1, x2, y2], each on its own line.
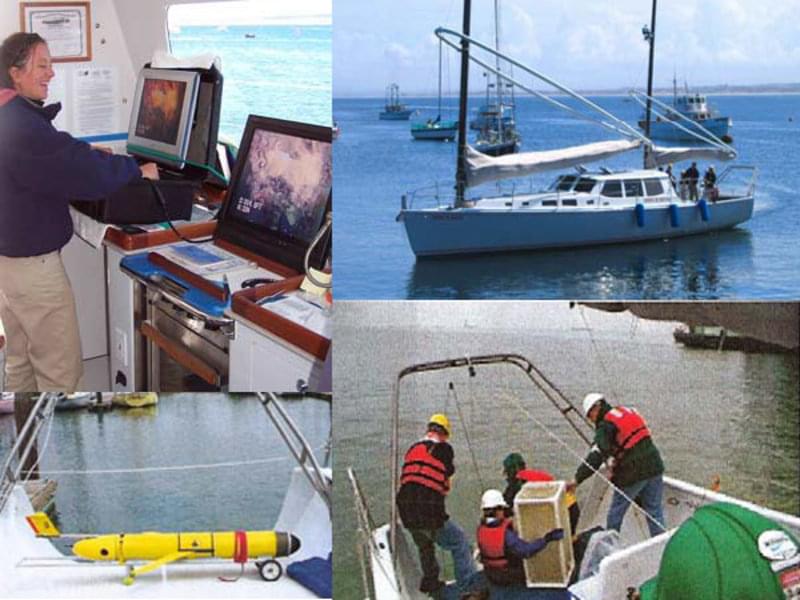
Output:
[0, 469, 331, 599]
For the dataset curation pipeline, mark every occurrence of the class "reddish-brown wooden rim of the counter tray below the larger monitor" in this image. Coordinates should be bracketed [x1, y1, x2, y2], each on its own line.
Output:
[231, 275, 331, 360]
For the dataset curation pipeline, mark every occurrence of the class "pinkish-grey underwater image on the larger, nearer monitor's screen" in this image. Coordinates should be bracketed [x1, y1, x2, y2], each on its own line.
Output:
[231, 129, 332, 242]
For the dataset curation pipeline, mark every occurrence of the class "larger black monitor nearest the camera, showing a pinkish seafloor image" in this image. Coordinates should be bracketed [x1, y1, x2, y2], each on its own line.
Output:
[217, 115, 333, 271]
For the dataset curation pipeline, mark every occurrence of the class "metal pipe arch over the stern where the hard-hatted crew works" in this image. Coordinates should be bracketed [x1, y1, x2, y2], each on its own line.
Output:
[389, 354, 591, 580]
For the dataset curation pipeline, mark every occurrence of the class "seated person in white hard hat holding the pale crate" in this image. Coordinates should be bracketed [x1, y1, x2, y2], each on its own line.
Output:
[476, 490, 564, 598]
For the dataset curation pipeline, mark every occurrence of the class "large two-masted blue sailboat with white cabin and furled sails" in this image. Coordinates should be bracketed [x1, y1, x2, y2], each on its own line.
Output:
[397, 0, 757, 257]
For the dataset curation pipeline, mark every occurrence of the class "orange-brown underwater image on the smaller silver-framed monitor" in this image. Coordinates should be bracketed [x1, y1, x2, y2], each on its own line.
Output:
[136, 79, 186, 144]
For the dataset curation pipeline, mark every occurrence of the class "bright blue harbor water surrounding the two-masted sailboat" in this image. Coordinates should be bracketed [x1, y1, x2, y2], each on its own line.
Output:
[333, 95, 800, 299]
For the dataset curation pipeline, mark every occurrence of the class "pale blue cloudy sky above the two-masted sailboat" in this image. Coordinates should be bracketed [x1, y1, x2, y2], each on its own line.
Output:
[333, 0, 800, 97]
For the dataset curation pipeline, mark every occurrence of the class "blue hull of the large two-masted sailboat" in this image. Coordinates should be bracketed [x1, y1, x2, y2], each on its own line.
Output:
[400, 196, 753, 257]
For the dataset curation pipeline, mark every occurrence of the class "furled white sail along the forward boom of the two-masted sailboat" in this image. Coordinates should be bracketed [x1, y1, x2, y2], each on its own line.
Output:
[466, 140, 642, 187]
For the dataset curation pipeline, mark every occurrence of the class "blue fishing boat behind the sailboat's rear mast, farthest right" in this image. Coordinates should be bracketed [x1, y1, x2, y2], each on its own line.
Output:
[639, 80, 733, 143]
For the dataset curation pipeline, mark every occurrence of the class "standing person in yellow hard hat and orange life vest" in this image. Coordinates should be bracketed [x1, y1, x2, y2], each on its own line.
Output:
[397, 414, 475, 594]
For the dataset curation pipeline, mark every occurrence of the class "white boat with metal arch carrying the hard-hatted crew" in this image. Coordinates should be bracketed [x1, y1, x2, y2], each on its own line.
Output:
[348, 354, 800, 600]
